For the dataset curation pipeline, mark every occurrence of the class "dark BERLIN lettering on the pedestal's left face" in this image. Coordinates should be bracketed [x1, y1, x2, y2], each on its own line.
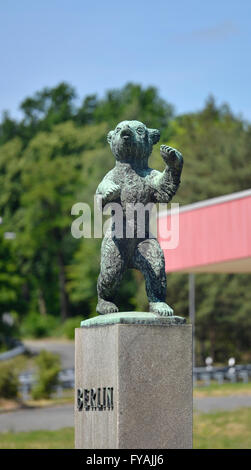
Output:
[77, 387, 113, 411]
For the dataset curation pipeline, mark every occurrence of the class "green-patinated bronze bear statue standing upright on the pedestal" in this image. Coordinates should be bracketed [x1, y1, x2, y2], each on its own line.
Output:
[96, 121, 183, 316]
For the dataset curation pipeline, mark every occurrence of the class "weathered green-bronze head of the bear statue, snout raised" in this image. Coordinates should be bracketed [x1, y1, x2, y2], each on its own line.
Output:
[107, 121, 160, 168]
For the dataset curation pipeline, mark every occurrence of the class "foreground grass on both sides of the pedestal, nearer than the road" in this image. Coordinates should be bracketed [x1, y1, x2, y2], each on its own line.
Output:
[0, 408, 251, 449]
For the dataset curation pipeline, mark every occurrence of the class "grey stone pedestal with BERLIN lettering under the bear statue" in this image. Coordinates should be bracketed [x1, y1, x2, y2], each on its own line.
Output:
[75, 312, 192, 449]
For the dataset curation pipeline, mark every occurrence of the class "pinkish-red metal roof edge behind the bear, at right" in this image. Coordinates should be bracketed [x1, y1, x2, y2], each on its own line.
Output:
[159, 190, 251, 272]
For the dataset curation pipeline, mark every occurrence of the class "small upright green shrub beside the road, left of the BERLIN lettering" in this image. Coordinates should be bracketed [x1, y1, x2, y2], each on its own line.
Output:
[31, 350, 60, 400]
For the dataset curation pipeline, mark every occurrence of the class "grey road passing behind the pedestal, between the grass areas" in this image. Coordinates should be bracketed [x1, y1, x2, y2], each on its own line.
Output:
[0, 395, 251, 432]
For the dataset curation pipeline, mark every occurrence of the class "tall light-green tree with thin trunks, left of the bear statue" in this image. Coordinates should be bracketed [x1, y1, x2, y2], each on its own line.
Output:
[16, 122, 88, 319]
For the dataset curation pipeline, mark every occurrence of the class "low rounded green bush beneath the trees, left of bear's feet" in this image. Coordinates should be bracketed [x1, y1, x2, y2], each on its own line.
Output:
[21, 312, 59, 338]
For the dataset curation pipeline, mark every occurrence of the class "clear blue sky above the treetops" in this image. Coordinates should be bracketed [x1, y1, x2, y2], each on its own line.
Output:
[0, 0, 251, 121]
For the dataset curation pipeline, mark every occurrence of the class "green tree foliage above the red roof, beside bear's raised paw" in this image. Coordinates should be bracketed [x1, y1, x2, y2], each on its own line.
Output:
[163, 98, 251, 204]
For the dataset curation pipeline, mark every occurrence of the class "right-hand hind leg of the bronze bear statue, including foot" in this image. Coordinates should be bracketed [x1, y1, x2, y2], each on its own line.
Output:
[134, 238, 173, 316]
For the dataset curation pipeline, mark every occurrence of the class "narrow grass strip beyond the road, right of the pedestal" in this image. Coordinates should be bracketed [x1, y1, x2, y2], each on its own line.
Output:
[194, 382, 251, 398]
